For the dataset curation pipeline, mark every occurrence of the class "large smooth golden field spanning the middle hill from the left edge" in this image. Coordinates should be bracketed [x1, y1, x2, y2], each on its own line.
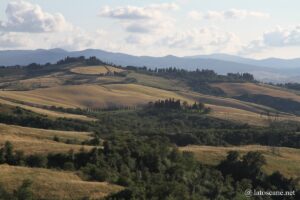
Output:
[0, 84, 192, 108]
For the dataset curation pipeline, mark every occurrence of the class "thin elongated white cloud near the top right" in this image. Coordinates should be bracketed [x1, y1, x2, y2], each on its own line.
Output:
[188, 9, 270, 20]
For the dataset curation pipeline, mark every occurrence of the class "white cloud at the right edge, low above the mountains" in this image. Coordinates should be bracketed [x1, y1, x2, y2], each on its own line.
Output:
[240, 25, 300, 54]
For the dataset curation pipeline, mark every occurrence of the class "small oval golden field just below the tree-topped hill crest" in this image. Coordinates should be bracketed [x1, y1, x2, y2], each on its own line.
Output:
[70, 66, 124, 75]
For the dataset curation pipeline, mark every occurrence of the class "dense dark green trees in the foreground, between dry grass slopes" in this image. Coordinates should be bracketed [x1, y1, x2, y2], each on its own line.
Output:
[3, 134, 299, 200]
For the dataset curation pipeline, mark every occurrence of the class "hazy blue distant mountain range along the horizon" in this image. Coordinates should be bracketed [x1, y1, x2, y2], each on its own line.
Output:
[0, 49, 300, 82]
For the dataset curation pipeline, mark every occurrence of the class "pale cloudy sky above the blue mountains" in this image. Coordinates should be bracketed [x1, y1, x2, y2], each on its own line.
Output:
[0, 0, 300, 59]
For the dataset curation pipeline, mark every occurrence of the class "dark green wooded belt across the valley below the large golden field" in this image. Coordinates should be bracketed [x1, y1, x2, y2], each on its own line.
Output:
[0, 104, 300, 148]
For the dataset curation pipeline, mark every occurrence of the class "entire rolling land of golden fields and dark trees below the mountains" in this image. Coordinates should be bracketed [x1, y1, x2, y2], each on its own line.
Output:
[0, 57, 300, 200]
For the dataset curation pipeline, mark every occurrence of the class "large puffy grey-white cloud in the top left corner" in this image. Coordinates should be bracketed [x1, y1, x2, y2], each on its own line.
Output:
[0, 0, 72, 33]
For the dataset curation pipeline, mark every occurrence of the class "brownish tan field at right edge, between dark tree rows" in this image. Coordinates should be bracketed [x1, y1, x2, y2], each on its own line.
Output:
[211, 83, 300, 102]
